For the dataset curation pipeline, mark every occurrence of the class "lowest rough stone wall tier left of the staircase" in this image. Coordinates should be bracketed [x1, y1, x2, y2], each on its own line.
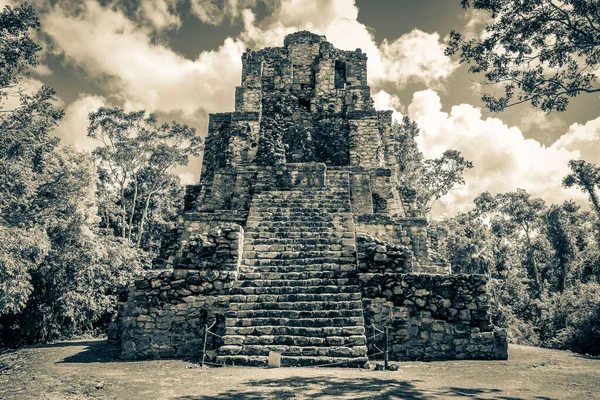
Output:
[109, 269, 233, 360]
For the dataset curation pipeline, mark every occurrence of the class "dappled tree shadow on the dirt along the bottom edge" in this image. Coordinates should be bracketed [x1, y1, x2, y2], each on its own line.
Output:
[176, 376, 547, 400]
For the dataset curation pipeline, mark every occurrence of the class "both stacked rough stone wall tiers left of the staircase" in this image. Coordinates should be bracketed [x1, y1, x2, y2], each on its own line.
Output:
[109, 224, 244, 359]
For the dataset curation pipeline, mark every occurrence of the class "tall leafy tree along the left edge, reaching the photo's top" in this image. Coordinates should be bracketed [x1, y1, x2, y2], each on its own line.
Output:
[0, 4, 63, 227]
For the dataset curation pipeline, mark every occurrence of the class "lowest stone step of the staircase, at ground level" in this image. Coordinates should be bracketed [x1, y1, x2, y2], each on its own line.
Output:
[217, 355, 369, 368]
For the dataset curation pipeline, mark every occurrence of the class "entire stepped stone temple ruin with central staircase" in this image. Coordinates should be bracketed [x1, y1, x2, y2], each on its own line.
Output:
[109, 32, 507, 366]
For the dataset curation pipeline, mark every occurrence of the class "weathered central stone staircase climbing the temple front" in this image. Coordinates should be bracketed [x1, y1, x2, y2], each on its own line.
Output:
[217, 172, 368, 366]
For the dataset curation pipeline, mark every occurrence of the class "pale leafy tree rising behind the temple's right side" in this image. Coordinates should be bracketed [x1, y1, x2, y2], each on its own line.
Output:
[392, 116, 473, 214]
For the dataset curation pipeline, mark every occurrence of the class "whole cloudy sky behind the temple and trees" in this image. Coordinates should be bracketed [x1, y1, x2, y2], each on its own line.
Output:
[7, 0, 600, 214]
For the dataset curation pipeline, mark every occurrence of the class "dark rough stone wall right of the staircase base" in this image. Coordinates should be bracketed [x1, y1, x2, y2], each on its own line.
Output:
[359, 273, 508, 361]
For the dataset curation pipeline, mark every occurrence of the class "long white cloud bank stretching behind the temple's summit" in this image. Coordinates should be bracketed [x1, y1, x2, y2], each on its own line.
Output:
[42, 0, 460, 127]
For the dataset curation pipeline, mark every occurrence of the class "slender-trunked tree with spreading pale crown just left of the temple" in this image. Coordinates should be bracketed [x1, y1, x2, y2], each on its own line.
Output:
[88, 107, 202, 247]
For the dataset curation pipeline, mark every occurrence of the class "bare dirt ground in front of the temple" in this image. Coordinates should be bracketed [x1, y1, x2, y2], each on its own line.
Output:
[0, 340, 600, 400]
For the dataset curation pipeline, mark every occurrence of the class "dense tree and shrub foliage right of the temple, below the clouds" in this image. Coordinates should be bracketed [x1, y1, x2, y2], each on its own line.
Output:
[434, 184, 600, 354]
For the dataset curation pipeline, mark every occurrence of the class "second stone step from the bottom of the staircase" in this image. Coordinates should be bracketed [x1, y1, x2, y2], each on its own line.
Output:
[219, 344, 367, 357]
